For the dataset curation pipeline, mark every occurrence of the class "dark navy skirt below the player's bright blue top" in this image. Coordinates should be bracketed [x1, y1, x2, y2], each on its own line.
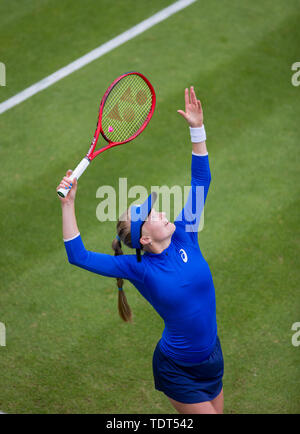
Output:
[152, 337, 224, 404]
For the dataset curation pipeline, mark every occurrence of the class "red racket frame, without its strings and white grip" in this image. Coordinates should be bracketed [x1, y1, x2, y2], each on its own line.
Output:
[86, 71, 156, 161]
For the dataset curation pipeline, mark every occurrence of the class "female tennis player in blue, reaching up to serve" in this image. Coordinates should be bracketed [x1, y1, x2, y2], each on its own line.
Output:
[57, 87, 224, 414]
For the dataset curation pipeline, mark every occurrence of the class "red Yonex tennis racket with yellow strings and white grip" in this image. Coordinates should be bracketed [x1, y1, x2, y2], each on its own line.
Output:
[57, 72, 156, 197]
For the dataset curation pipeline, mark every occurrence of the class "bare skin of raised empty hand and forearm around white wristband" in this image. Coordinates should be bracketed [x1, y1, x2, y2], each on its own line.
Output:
[177, 86, 207, 155]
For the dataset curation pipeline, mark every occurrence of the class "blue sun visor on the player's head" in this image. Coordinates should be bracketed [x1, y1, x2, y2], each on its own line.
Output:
[130, 192, 157, 262]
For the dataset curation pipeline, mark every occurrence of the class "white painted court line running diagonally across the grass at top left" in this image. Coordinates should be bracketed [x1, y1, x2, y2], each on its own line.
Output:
[0, 0, 197, 114]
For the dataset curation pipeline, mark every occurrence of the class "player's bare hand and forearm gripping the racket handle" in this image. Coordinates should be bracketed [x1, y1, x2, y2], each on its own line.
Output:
[56, 170, 79, 240]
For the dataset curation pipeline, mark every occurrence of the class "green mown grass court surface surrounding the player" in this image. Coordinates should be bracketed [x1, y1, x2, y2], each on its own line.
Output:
[0, 0, 300, 413]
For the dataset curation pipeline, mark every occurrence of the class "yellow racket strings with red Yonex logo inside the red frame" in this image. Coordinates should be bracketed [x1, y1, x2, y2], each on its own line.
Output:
[102, 74, 152, 142]
